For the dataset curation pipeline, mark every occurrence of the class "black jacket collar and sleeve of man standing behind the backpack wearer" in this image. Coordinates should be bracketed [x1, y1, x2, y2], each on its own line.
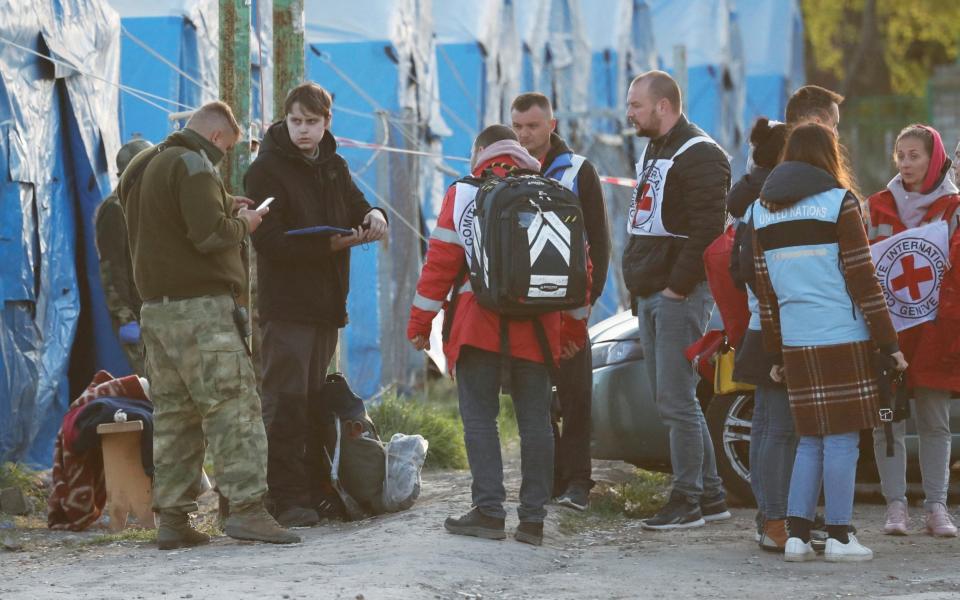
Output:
[541, 133, 610, 304]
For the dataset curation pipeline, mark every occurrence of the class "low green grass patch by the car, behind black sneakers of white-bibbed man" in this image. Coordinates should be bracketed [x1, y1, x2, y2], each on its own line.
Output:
[560, 469, 670, 533]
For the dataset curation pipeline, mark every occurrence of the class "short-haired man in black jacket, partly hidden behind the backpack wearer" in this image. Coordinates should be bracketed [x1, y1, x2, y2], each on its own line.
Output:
[510, 92, 610, 510]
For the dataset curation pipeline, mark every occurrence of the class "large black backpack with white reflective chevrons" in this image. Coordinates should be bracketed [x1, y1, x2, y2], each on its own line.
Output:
[460, 174, 587, 318]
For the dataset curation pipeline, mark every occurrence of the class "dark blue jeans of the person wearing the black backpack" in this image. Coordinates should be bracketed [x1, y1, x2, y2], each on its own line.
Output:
[456, 346, 553, 522]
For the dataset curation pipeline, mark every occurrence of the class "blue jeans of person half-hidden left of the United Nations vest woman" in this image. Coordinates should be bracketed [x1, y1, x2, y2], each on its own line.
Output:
[750, 381, 797, 521]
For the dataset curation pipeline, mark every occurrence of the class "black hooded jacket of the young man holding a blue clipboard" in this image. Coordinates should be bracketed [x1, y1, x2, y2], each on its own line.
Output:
[244, 121, 386, 327]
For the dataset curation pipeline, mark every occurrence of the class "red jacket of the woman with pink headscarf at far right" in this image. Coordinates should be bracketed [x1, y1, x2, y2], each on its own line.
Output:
[867, 189, 960, 391]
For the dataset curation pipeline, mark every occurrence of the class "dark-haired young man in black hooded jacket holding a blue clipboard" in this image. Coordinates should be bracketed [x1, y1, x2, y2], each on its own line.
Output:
[245, 83, 387, 526]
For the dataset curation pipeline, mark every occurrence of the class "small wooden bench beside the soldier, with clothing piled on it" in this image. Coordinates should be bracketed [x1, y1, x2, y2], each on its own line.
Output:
[97, 421, 156, 531]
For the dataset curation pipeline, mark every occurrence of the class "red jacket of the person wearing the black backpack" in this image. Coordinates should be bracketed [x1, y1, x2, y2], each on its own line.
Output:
[407, 152, 592, 373]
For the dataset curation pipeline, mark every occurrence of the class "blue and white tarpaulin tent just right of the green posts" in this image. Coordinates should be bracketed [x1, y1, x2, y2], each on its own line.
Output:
[306, 0, 442, 398]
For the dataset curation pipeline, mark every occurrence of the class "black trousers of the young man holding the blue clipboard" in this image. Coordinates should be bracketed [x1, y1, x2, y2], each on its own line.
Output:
[261, 321, 337, 508]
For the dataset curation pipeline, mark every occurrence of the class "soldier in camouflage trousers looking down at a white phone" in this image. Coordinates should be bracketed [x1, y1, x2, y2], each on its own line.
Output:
[119, 102, 300, 549]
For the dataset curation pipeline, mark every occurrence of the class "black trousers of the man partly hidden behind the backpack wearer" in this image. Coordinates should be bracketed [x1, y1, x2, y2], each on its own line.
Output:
[553, 340, 593, 497]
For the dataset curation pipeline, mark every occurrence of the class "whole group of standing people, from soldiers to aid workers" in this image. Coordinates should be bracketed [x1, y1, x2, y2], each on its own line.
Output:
[97, 71, 960, 561]
